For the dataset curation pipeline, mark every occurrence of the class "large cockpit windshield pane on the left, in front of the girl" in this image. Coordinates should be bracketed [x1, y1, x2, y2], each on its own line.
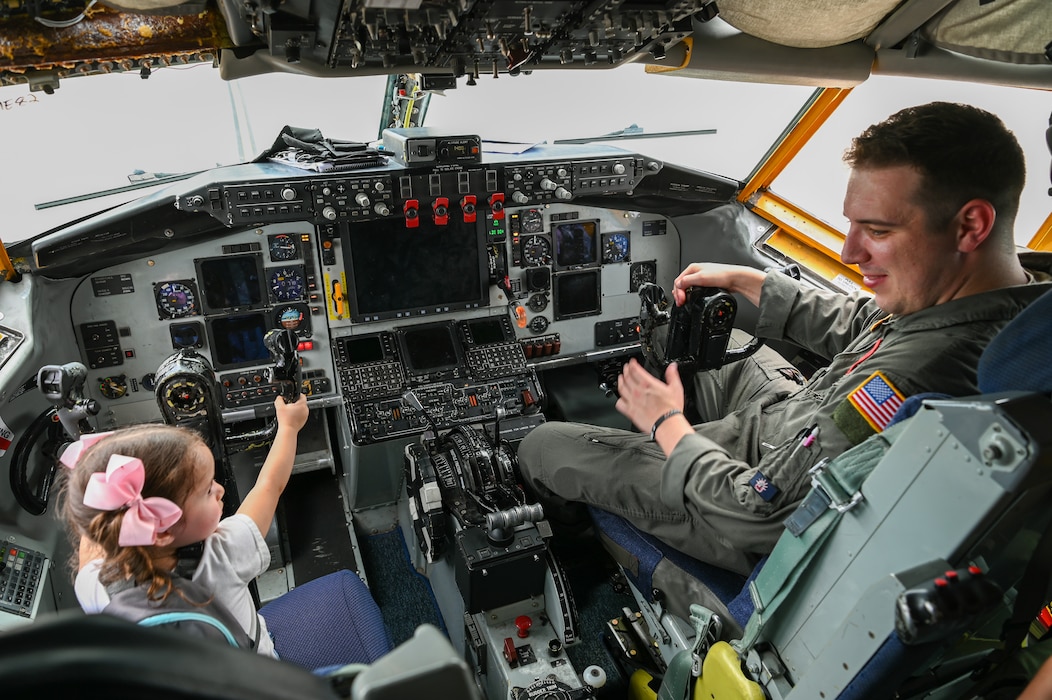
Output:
[0, 65, 387, 244]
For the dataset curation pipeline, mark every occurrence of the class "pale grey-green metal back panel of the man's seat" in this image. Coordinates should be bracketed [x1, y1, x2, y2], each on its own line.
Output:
[763, 399, 1052, 698]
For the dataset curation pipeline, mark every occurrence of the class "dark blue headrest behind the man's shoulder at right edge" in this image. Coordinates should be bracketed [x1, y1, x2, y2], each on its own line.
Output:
[978, 292, 1052, 394]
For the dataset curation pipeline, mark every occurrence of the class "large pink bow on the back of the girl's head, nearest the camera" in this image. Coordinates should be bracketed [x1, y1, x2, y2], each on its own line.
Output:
[82, 455, 183, 547]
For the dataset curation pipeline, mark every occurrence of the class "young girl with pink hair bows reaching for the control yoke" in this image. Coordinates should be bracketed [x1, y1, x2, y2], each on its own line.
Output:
[60, 396, 308, 656]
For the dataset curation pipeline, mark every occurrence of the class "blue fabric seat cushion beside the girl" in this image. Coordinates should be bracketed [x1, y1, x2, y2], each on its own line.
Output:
[260, 571, 391, 669]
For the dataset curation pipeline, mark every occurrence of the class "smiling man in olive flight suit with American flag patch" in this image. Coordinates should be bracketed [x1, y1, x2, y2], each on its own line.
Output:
[519, 102, 1052, 574]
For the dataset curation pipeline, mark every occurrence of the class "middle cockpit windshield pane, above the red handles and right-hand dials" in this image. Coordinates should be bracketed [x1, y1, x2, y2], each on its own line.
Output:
[424, 64, 814, 180]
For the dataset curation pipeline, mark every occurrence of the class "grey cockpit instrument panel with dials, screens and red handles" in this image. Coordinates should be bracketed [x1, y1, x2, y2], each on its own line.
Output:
[65, 140, 694, 444]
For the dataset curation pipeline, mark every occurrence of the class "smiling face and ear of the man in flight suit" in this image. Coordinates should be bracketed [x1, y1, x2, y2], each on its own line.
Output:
[841, 165, 962, 314]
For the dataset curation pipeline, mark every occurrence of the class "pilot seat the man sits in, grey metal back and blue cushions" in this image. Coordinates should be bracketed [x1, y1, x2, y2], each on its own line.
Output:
[592, 286, 1052, 700]
